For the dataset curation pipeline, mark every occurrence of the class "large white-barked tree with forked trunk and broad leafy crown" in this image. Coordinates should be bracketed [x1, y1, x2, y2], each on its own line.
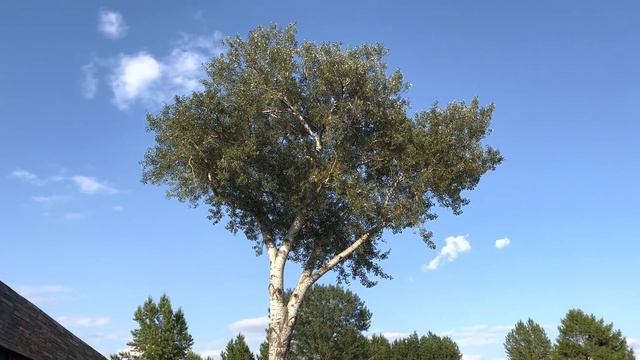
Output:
[144, 26, 502, 360]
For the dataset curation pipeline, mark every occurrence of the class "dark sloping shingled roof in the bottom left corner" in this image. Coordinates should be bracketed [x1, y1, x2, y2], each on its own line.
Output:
[0, 281, 105, 360]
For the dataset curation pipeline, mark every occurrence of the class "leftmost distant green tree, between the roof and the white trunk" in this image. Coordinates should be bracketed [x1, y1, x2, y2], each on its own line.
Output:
[112, 295, 194, 360]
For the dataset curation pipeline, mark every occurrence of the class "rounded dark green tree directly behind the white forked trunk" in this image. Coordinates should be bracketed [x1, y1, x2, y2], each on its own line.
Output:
[289, 285, 371, 360]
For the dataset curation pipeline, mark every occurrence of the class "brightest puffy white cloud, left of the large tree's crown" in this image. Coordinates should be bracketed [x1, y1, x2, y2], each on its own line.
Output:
[111, 52, 161, 109]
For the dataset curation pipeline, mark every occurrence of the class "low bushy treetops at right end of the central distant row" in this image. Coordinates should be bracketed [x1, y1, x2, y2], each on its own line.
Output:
[388, 332, 462, 360]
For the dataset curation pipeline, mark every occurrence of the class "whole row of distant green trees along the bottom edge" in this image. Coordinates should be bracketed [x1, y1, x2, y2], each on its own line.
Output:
[111, 285, 635, 360]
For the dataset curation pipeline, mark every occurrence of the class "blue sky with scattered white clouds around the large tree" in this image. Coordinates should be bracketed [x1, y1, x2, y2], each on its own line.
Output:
[0, 0, 640, 360]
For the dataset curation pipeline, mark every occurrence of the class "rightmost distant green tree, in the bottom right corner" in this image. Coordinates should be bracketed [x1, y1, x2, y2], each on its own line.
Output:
[555, 309, 635, 360]
